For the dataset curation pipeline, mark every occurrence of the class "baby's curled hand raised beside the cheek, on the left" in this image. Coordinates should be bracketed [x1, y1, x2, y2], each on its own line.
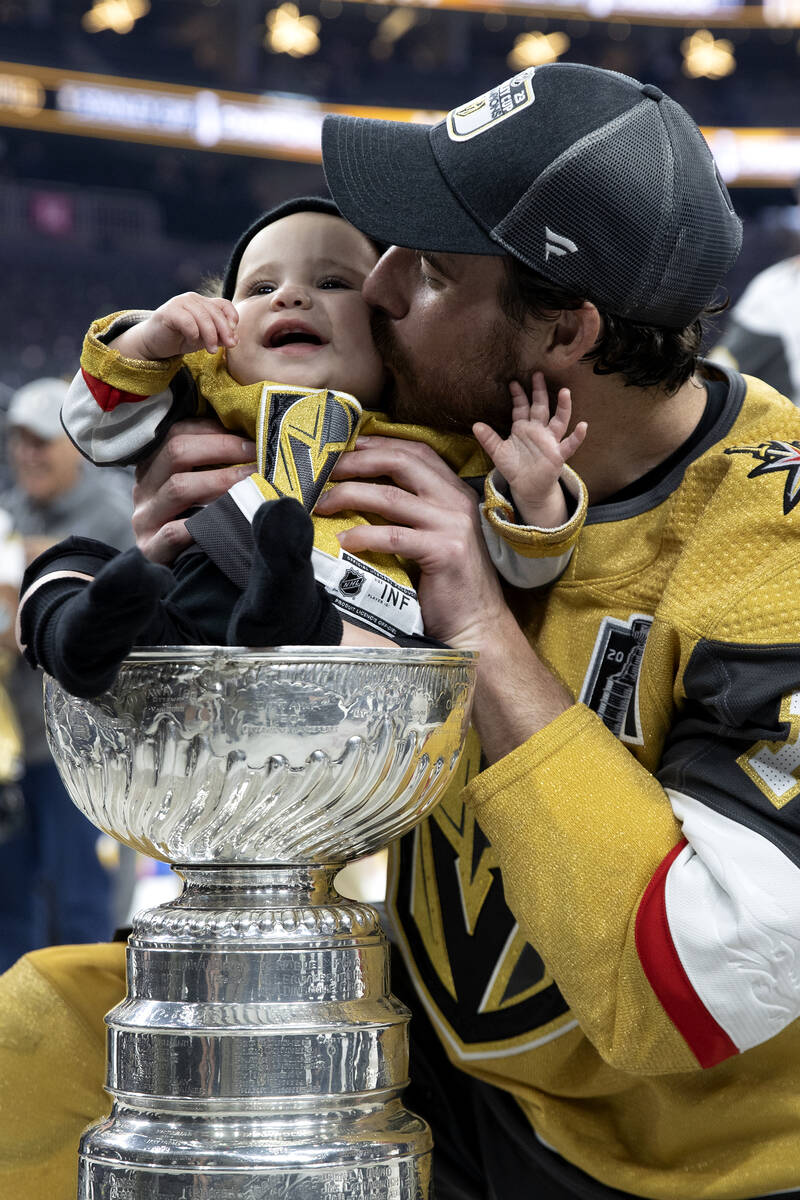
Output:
[112, 292, 239, 361]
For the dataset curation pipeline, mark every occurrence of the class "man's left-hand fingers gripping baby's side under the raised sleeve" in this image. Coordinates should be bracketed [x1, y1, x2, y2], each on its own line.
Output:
[133, 419, 255, 563]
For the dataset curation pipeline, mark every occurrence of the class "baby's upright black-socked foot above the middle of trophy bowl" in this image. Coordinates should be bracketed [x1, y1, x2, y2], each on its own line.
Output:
[228, 497, 342, 646]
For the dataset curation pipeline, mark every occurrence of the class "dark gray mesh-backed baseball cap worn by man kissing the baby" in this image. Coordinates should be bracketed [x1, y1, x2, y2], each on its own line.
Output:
[323, 62, 741, 329]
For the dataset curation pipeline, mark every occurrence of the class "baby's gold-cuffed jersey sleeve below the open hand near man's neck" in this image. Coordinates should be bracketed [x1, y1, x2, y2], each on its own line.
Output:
[480, 467, 588, 588]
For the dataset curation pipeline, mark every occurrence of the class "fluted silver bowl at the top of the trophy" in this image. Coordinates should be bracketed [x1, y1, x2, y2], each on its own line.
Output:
[44, 646, 476, 866]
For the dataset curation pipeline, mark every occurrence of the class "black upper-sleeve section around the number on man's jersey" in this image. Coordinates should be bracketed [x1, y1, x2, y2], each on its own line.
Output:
[656, 640, 800, 866]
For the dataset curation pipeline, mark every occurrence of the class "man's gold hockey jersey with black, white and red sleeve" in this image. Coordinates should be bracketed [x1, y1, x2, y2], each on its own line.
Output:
[390, 368, 800, 1200]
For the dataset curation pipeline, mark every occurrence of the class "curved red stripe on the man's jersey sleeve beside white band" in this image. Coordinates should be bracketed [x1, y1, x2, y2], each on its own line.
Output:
[636, 838, 739, 1067]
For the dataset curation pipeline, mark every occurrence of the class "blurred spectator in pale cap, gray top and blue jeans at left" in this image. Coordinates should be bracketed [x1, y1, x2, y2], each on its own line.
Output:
[0, 379, 133, 971]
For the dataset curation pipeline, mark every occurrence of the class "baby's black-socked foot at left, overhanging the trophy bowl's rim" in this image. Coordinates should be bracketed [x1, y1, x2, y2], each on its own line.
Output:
[20, 547, 174, 698]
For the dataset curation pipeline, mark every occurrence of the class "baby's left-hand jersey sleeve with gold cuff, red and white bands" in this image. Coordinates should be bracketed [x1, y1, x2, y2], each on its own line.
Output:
[61, 312, 205, 467]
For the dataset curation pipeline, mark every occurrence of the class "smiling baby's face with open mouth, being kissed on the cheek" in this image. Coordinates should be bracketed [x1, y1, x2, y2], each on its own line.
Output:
[227, 212, 384, 408]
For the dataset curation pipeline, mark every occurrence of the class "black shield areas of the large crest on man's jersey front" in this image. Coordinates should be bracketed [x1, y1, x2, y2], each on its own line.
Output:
[396, 820, 567, 1045]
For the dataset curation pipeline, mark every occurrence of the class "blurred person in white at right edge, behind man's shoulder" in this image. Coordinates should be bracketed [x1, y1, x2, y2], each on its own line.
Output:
[708, 188, 800, 406]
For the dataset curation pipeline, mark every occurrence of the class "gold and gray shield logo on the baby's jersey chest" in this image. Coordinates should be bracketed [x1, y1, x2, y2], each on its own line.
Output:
[257, 386, 361, 512]
